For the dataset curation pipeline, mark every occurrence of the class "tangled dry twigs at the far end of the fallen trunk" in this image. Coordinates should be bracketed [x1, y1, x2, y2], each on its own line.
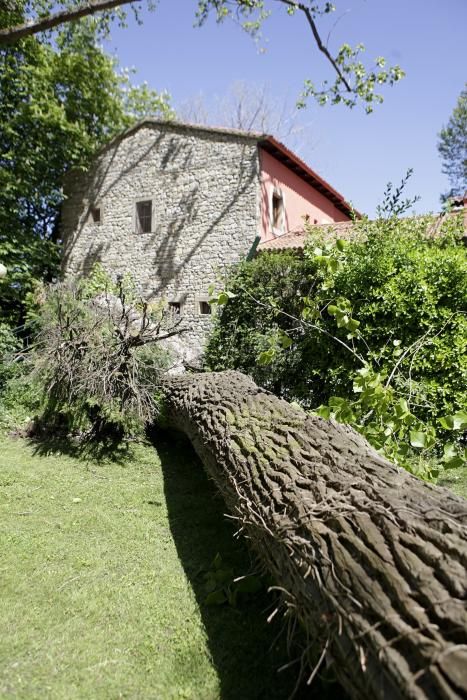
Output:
[33, 282, 183, 434]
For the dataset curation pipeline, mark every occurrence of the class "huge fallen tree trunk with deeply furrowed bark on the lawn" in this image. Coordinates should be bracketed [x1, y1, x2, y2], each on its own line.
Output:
[165, 372, 467, 700]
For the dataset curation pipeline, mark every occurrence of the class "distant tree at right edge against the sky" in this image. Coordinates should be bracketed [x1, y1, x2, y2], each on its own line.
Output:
[438, 83, 467, 198]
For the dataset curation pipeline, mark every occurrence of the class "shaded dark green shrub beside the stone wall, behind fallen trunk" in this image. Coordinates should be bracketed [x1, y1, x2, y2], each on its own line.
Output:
[205, 252, 322, 396]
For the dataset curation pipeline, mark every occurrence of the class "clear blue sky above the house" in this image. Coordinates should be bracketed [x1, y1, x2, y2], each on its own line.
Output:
[108, 0, 467, 215]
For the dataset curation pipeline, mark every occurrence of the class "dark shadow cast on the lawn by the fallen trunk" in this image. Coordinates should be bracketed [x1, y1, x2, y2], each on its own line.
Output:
[152, 432, 343, 700]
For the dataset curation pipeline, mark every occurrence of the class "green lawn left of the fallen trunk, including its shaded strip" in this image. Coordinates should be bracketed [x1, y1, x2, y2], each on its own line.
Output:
[0, 438, 314, 700]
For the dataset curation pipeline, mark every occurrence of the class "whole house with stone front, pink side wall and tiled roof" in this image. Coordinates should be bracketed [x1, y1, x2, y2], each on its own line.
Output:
[61, 119, 351, 350]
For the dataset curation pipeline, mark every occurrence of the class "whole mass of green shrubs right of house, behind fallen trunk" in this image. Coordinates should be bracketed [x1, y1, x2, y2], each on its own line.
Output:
[206, 216, 467, 471]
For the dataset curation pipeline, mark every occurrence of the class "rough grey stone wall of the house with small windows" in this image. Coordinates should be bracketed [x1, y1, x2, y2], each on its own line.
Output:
[62, 123, 260, 352]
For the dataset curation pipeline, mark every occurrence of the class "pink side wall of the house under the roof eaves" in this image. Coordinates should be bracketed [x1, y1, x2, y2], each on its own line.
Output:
[259, 146, 350, 241]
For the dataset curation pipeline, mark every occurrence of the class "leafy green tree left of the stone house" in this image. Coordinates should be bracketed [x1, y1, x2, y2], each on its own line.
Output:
[0, 10, 172, 324]
